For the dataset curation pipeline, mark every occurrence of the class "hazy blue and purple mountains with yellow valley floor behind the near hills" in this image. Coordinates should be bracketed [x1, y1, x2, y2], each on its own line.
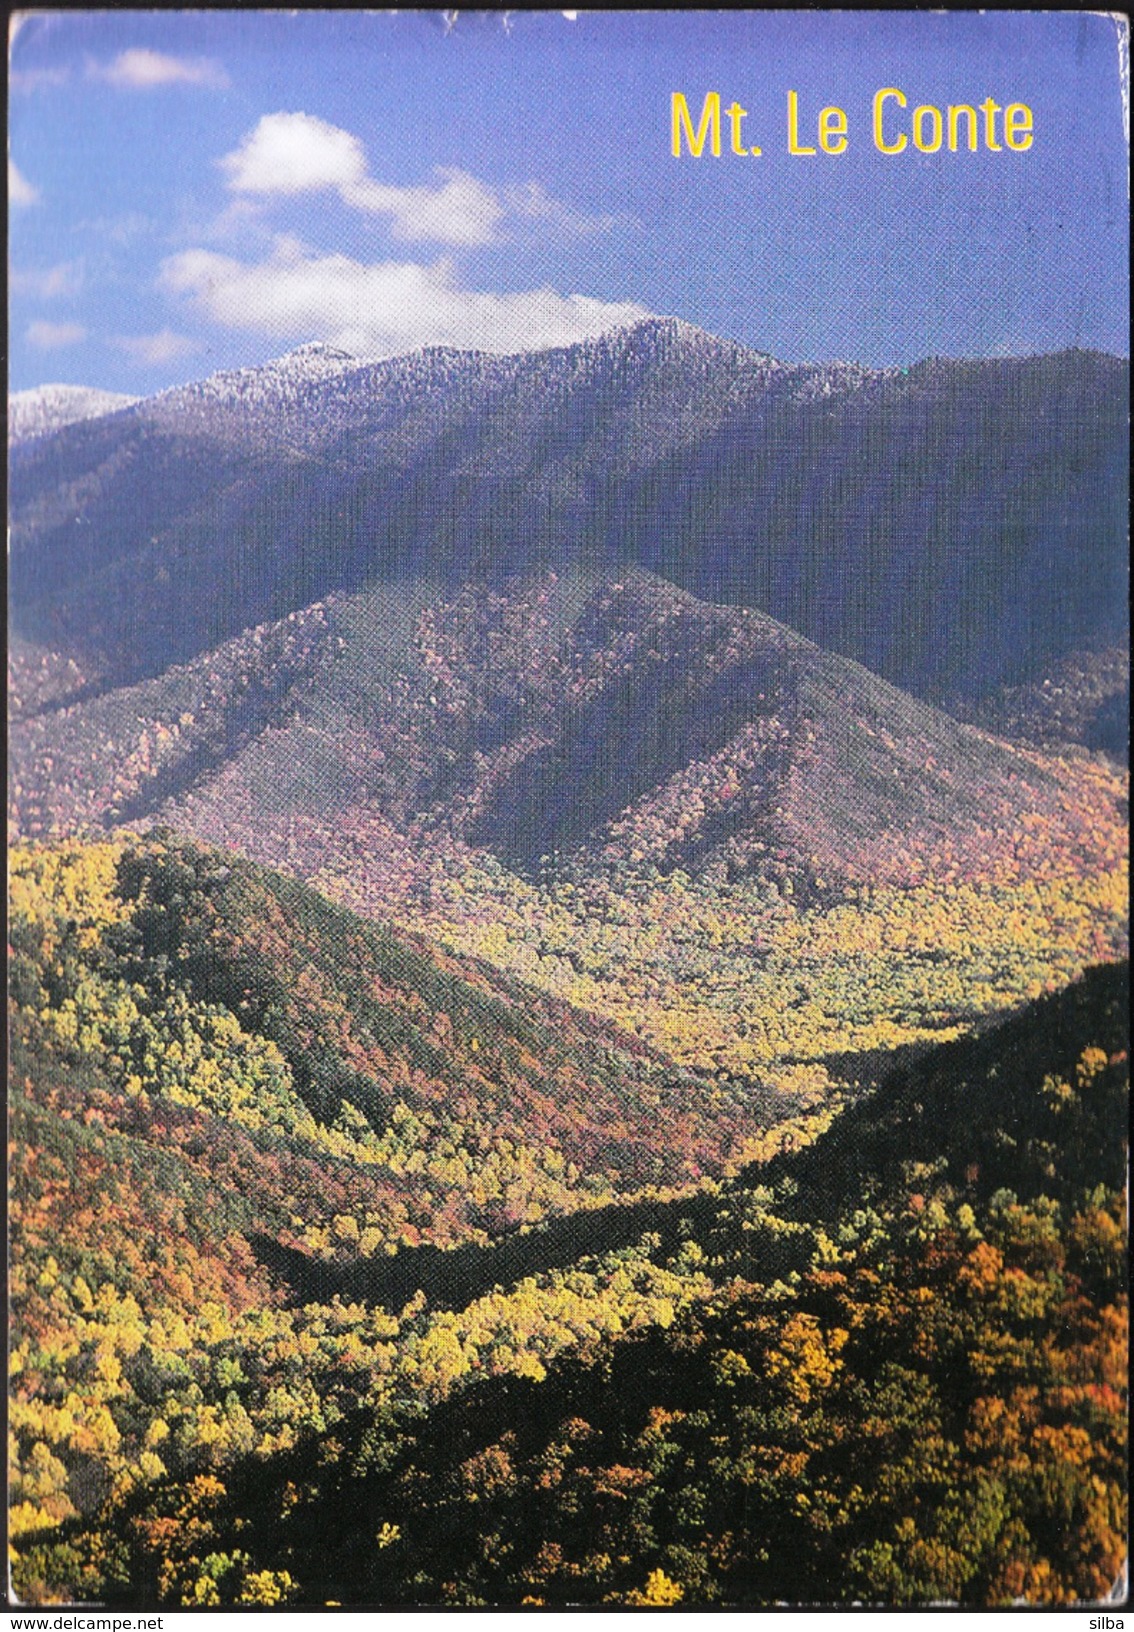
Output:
[8, 320, 1129, 1097]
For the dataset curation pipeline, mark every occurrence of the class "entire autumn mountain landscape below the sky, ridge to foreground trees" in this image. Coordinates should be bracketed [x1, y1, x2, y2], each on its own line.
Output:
[8, 320, 1129, 1608]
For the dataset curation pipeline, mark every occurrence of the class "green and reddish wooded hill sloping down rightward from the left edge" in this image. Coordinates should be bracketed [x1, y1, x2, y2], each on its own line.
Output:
[11, 834, 793, 1245]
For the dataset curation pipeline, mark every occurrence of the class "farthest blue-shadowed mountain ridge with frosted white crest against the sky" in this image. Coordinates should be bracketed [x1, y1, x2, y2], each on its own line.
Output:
[11, 320, 1127, 714]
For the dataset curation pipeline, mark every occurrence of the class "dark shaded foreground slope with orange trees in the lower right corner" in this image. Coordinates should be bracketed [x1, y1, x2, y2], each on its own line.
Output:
[226, 971, 1129, 1608]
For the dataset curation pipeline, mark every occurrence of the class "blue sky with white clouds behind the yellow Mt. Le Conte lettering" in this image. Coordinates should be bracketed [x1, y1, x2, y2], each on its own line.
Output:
[10, 11, 1127, 393]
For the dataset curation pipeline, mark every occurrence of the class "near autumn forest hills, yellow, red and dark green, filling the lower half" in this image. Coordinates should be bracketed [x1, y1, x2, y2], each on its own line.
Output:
[10, 832, 1127, 1606]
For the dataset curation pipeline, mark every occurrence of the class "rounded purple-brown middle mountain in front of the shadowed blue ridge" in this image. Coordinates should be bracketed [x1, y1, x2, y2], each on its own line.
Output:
[11, 568, 1114, 886]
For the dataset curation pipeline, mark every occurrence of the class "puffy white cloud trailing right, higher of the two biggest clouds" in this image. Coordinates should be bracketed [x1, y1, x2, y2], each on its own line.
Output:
[220, 113, 614, 246]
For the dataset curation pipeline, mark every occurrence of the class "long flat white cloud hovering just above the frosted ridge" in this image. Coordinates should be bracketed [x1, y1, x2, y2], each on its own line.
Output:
[162, 238, 648, 357]
